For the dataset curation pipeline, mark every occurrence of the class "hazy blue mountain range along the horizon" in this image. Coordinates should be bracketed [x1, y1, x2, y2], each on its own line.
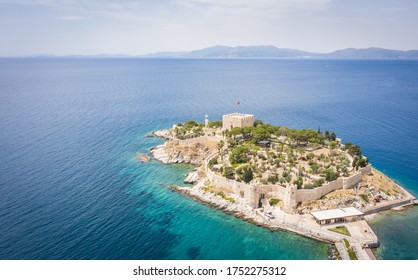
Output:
[143, 46, 418, 59]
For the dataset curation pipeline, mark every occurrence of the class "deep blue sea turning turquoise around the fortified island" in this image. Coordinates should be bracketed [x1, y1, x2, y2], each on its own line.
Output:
[0, 58, 418, 259]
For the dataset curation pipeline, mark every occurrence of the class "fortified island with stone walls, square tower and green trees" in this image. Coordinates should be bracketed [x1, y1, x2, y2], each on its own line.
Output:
[151, 113, 417, 260]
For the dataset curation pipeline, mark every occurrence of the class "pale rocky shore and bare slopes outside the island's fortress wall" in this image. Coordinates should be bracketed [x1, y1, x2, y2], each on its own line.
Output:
[148, 127, 414, 259]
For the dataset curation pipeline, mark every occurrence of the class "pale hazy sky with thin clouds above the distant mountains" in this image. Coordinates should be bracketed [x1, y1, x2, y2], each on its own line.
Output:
[0, 0, 418, 56]
